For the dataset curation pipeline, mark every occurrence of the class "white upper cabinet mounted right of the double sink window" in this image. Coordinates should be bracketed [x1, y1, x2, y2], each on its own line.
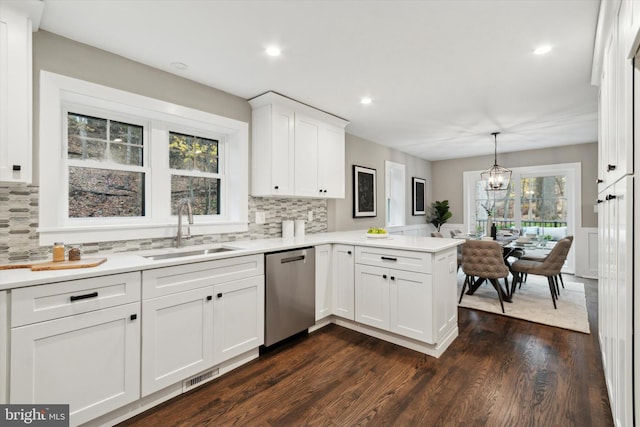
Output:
[249, 92, 348, 198]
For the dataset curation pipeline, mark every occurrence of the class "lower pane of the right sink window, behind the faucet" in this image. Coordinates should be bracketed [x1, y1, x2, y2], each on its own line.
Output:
[171, 175, 220, 215]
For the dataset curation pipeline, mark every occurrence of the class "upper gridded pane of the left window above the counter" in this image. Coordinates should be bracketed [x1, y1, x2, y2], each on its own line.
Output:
[67, 113, 143, 166]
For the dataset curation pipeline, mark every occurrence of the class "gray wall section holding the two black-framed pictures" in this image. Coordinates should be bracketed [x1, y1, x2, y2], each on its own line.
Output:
[327, 134, 431, 231]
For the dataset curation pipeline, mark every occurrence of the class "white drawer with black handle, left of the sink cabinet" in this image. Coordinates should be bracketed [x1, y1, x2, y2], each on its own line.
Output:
[11, 272, 140, 327]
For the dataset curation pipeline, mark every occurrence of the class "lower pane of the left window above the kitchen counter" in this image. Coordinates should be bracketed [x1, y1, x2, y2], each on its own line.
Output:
[69, 166, 144, 218]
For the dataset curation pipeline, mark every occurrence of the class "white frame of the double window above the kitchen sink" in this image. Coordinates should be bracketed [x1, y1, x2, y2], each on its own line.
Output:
[38, 71, 249, 245]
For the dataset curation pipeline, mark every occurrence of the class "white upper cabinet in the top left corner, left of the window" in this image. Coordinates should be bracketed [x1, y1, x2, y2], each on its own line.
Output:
[0, 0, 44, 185]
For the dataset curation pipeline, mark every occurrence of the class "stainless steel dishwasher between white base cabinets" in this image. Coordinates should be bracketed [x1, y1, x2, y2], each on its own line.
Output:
[264, 248, 316, 347]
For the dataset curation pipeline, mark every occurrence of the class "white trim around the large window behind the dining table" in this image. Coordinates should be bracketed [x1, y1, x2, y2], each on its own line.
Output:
[463, 163, 582, 273]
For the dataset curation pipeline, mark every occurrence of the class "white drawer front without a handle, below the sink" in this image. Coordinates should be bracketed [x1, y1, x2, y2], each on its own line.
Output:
[142, 254, 264, 299]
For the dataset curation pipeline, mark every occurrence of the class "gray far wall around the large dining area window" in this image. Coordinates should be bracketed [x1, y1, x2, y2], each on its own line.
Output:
[431, 143, 598, 227]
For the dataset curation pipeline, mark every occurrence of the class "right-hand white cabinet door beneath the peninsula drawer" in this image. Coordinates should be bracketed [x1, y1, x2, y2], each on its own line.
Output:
[389, 270, 434, 343]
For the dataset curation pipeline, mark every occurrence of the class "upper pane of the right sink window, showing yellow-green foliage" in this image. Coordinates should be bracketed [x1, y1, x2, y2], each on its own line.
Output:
[169, 132, 218, 173]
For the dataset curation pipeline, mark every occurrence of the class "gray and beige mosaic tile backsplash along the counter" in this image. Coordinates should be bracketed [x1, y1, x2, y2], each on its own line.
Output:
[0, 186, 327, 264]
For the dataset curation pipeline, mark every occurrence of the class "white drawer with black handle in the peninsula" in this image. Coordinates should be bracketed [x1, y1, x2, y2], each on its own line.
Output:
[356, 246, 431, 274]
